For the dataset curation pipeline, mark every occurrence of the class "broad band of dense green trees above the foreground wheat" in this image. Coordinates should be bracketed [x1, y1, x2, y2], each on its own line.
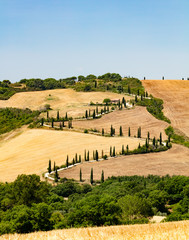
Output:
[0, 173, 189, 234]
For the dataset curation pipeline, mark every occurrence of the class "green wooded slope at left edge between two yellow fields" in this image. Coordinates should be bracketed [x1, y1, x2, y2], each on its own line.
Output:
[0, 108, 40, 134]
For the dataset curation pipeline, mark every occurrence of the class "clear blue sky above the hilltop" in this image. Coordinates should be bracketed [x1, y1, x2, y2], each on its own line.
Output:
[0, 0, 189, 82]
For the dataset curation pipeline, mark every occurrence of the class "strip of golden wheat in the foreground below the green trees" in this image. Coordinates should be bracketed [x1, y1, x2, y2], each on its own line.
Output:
[0, 221, 189, 240]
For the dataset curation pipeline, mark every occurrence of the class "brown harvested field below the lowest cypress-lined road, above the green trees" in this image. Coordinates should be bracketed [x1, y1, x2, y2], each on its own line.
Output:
[59, 144, 189, 181]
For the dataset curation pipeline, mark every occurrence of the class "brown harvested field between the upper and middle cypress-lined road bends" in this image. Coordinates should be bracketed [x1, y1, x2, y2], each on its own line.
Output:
[73, 106, 169, 139]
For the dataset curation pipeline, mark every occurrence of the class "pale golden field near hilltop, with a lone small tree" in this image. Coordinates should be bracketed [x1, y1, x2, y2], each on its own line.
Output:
[0, 89, 133, 117]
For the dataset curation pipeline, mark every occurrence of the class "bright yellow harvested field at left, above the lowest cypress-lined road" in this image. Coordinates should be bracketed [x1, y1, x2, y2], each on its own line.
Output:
[0, 128, 144, 181]
